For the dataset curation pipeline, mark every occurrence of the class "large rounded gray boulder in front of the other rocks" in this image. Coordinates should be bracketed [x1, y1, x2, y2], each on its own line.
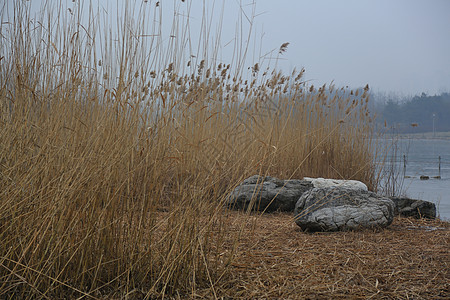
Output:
[294, 187, 395, 231]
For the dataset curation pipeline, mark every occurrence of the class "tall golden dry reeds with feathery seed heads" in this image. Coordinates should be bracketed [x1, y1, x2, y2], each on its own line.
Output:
[0, 1, 377, 299]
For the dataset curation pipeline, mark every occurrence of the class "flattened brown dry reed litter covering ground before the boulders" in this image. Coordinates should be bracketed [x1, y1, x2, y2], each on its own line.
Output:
[203, 212, 450, 299]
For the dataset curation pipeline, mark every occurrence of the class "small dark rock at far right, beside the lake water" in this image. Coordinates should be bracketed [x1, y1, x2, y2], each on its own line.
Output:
[389, 197, 436, 219]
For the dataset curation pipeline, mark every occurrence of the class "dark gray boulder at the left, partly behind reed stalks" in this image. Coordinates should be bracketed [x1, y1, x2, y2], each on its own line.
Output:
[227, 175, 313, 212]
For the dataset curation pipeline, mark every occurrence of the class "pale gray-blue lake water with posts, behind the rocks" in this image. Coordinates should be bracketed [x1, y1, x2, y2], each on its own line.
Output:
[378, 139, 450, 221]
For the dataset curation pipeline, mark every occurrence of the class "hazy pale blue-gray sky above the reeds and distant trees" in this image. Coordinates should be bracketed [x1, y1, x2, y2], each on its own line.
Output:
[15, 0, 450, 96]
